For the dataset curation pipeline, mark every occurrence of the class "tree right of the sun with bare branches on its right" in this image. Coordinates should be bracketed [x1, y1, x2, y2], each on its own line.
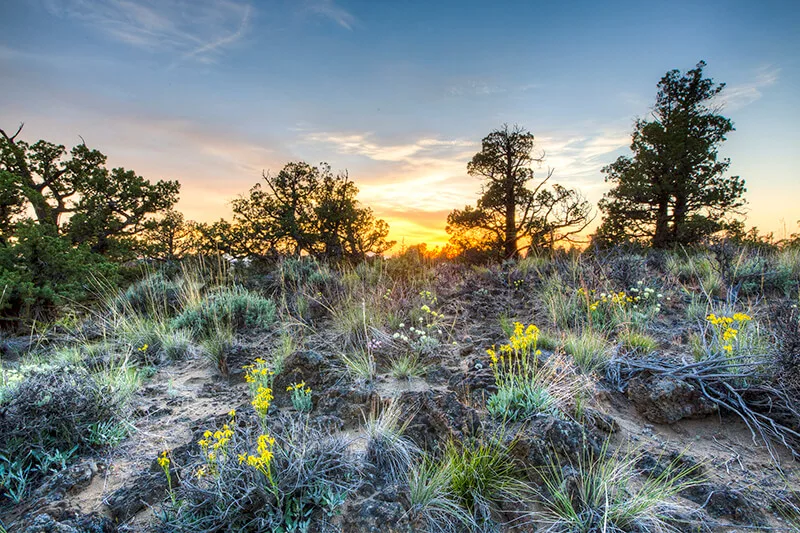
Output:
[447, 125, 592, 258]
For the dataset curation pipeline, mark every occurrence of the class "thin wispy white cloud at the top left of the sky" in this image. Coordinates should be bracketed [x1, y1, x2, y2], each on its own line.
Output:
[43, 0, 252, 62]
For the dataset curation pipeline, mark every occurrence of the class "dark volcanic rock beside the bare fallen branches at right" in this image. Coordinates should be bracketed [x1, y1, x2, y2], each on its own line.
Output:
[627, 376, 717, 424]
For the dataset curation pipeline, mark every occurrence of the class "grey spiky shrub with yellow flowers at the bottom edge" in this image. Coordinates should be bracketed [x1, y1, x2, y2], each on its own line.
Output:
[160, 416, 358, 533]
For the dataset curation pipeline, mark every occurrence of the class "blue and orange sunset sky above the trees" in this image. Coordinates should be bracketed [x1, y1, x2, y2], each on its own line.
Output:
[0, 0, 800, 245]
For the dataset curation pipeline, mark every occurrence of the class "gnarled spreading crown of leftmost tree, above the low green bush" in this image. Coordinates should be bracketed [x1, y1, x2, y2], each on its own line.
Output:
[0, 126, 180, 254]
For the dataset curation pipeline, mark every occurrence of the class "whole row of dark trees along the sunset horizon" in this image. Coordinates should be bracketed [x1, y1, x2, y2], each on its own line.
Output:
[0, 61, 800, 317]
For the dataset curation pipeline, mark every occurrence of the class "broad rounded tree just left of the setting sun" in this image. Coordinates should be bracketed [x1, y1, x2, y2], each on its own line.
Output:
[228, 162, 394, 259]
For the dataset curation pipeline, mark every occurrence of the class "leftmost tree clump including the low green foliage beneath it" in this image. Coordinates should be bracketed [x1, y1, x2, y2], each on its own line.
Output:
[0, 126, 179, 324]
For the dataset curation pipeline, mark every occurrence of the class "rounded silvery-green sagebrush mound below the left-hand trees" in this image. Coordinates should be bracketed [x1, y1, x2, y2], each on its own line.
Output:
[171, 287, 276, 338]
